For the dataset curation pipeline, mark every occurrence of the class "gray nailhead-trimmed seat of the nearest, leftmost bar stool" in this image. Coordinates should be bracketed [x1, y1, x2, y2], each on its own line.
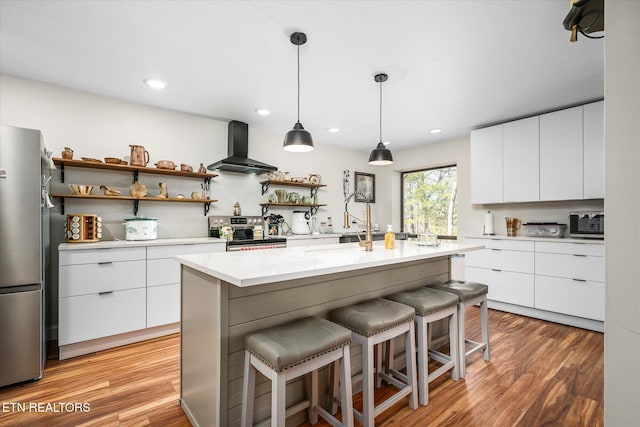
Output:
[245, 317, 351, 372]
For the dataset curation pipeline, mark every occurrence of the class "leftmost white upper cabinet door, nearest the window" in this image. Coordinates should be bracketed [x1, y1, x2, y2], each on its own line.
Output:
[470, 125, 503, 204]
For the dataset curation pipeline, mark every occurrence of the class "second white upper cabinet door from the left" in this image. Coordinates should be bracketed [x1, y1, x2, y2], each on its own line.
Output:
[502, 116, 540, 202]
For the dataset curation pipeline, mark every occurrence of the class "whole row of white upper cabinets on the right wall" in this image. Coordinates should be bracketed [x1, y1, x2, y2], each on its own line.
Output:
[470, 101, 604, 204]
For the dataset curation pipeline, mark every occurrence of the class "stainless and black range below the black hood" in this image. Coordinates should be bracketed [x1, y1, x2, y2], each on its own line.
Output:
[209, 216, 287, 252]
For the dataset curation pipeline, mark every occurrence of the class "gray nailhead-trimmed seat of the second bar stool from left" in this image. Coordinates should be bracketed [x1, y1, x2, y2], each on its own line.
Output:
[331, 298, 415, 337]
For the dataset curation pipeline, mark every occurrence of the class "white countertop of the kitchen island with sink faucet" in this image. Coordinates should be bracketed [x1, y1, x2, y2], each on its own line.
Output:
[176, 240, 484, 287]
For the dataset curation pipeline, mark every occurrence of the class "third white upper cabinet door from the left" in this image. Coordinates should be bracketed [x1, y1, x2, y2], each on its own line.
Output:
[540, 106, 584, 201]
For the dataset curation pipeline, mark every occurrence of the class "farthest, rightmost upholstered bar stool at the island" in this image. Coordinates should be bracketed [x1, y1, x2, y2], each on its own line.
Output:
[428, 280, 490, 378]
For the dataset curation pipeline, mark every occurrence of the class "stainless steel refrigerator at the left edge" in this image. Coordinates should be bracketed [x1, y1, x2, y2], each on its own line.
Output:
[0, 125, 50, 387]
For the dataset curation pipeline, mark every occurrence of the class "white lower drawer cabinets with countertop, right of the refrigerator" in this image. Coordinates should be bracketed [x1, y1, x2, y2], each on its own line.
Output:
[58, 243, 226, 347]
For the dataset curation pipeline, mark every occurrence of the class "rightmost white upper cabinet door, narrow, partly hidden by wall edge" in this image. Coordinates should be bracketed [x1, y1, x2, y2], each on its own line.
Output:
[583, 101, 604, 199]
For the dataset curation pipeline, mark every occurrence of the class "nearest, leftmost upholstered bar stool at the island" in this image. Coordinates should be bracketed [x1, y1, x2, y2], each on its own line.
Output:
[241, 317, 353, 427]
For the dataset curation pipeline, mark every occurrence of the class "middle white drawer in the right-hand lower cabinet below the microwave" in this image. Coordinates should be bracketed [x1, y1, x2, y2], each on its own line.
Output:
[536, 253, 604, 282]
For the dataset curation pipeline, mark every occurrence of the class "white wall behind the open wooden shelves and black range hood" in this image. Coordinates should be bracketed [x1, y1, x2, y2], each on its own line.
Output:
[0, 75, 384, 336]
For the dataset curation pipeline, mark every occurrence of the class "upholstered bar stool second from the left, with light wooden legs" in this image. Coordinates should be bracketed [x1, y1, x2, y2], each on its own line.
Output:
[330, 298, 418, 427]
